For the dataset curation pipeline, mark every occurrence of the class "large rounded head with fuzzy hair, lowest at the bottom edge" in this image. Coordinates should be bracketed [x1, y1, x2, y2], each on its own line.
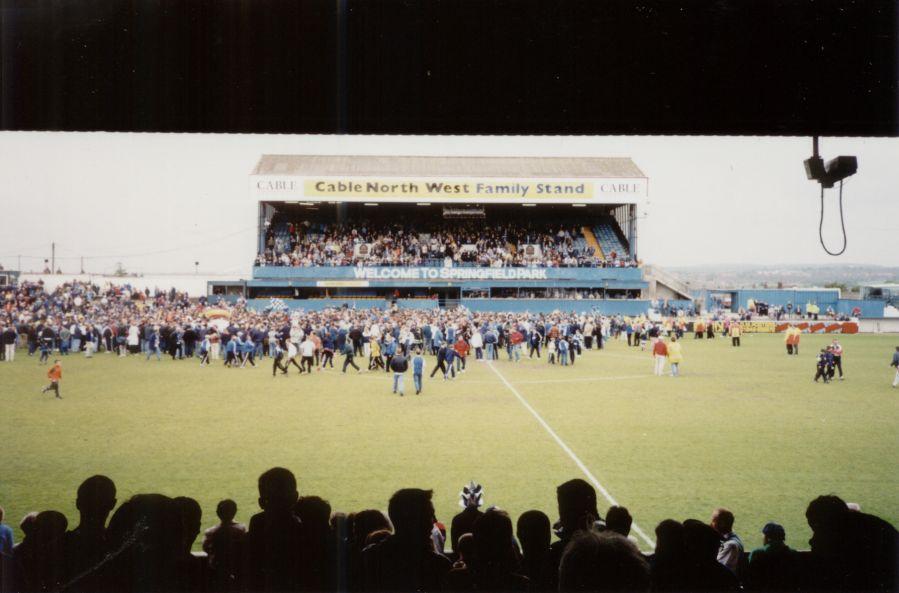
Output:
[559, 530, 650, 591]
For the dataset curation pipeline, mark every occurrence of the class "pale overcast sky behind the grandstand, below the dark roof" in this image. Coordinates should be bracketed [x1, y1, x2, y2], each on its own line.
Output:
[0, 132, 899, 277]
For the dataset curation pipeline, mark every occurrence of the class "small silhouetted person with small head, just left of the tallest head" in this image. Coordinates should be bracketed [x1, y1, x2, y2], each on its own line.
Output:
[203, 499, 247, 591]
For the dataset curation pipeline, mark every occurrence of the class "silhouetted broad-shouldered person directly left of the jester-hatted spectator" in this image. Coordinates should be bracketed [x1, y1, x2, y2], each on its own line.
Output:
[363, 488, 451, 591]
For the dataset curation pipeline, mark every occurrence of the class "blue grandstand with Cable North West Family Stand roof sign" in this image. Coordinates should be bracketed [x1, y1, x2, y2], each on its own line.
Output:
[209, 155, 692, 314]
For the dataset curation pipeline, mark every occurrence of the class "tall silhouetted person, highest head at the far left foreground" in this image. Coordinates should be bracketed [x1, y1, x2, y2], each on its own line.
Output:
[65, 475, 116, 593]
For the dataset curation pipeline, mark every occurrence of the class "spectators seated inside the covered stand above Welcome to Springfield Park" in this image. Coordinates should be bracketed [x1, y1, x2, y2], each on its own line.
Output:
[255, 221, 636, 268]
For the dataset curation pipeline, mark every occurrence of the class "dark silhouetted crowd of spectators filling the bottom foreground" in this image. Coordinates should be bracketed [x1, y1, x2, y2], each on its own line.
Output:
[0, 468, 897, 593]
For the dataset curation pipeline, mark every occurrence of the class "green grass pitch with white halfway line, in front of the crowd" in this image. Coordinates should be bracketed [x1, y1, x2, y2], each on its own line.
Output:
[0, 335, 899, 549]
